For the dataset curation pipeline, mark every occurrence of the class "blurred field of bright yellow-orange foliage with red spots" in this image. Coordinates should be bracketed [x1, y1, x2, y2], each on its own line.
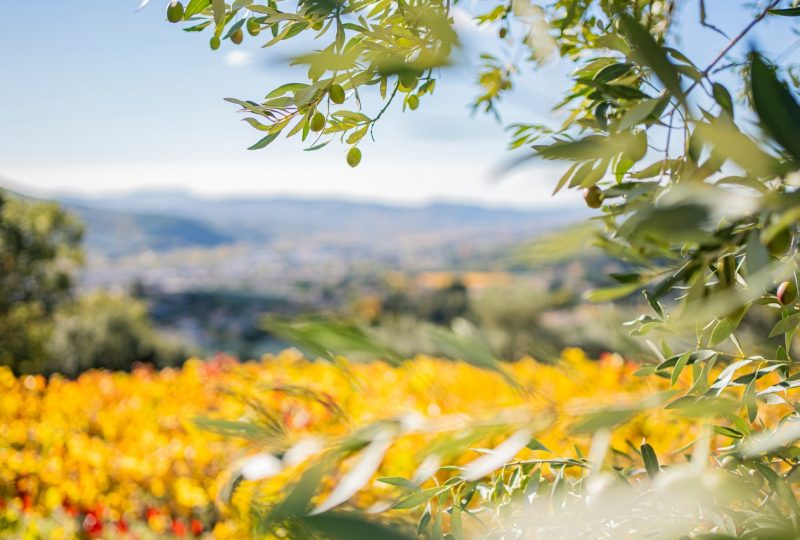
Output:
[0, 349, 780, 538]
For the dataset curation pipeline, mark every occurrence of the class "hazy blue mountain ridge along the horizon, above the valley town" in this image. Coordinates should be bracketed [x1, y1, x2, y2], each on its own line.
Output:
[57, 191, 583, 253]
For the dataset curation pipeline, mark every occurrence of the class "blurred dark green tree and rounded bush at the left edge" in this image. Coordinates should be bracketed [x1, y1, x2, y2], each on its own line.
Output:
[0, 190, 189, 376]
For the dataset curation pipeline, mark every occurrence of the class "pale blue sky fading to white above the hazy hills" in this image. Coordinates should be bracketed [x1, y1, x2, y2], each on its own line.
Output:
[0, 0, 793, 206]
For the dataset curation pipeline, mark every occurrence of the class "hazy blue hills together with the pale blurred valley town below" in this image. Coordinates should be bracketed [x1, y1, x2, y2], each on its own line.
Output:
[1, 186, 587, 294]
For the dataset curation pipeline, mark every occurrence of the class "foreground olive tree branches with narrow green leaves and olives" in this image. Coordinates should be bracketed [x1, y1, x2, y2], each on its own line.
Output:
[155, 0, 800, 538]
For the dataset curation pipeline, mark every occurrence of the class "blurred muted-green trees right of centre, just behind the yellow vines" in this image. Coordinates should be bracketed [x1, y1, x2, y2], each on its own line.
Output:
[352, 274, 650, 361]
